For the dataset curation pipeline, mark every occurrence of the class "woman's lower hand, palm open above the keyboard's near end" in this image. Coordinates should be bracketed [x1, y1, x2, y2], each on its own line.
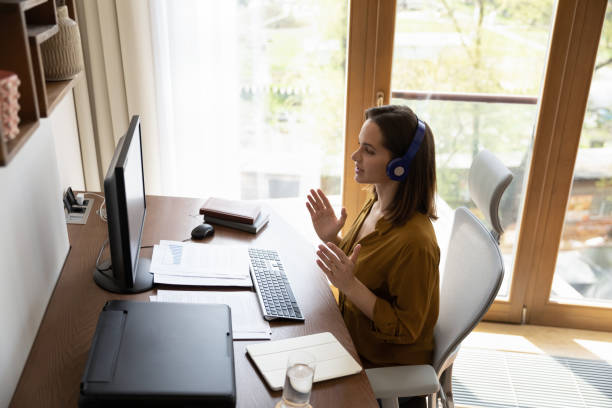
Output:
[317, 242, 361, 293]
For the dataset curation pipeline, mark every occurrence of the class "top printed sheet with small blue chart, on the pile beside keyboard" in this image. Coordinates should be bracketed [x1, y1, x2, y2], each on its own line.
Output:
[150, 241, 249, 280]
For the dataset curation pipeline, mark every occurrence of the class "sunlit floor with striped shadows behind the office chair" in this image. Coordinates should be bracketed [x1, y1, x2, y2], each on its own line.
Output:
[453, 322, 612, 408]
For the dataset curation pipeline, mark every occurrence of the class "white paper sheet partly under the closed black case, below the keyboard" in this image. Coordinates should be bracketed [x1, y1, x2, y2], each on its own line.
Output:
[150, 290, 272, 340]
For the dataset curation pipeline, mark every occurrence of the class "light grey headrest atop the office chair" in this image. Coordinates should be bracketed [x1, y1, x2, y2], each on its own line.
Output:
[468, 150, 512, 241]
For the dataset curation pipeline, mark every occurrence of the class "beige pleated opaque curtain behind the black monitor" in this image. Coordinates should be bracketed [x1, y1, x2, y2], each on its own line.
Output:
[75, 0, 161, 194]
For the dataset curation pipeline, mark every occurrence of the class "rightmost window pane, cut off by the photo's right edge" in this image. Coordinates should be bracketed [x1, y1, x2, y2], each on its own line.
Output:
[550, 2, 612, 306]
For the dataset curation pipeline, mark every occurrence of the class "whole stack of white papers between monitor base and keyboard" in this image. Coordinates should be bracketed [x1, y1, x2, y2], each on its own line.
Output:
[151, 241, 253, 287]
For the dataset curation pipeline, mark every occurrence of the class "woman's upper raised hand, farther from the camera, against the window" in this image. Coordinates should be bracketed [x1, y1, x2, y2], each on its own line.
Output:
[306, 189, 346, 243]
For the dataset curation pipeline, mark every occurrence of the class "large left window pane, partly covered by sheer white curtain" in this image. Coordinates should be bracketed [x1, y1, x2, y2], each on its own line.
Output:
[152, 0, 348, 202]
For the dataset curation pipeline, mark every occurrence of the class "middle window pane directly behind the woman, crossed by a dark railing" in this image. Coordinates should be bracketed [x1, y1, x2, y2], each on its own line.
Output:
[391, 0, 554, 297]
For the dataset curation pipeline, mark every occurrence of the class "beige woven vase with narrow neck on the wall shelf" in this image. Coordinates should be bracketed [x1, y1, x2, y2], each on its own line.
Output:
[40, 5, 83, 81]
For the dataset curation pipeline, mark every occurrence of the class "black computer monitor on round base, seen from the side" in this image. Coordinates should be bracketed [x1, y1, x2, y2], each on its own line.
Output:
[94, 116, 153, 293]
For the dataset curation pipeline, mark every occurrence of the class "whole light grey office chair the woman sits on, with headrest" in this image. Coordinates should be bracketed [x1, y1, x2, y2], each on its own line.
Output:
[366, 150, 512, 408]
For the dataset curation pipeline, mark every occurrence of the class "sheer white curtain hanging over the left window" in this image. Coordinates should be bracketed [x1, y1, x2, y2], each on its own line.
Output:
[151, 0, 240, 198]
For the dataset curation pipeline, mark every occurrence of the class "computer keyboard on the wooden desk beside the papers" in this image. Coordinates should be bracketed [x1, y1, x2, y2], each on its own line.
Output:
[249, 248, 304, 321]
